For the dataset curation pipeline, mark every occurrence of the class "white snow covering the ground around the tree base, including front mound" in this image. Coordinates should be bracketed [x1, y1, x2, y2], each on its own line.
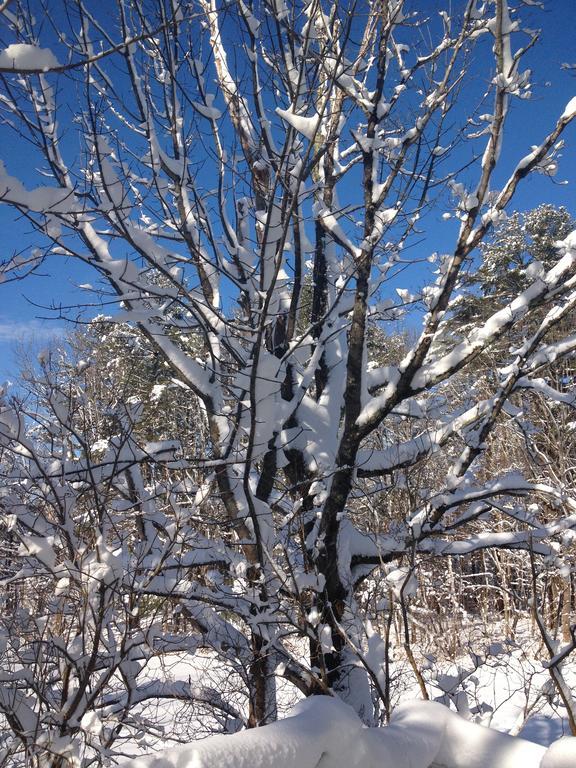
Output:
[117, 632, 576, 768]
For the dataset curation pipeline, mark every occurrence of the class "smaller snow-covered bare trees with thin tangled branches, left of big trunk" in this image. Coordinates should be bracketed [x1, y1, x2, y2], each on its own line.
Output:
[0, 350, 250, 768]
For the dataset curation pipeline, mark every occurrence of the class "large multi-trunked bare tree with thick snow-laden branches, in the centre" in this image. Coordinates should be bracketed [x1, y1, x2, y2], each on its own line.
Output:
[0, 0, 576, 760]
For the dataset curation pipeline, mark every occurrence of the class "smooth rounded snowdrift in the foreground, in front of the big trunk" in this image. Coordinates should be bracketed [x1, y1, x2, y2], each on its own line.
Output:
[124, 696, 576, 768]
